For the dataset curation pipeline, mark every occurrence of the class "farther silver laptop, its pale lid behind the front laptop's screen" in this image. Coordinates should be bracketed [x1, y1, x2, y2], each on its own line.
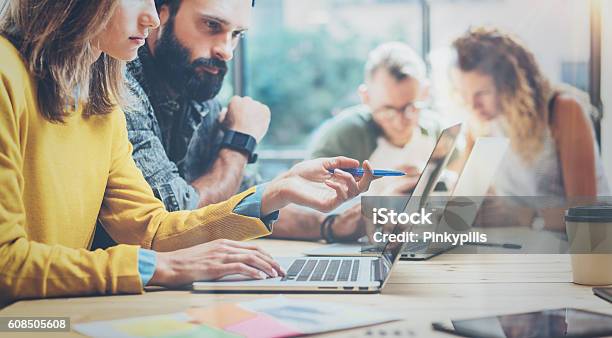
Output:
[305, 137, 509, 260]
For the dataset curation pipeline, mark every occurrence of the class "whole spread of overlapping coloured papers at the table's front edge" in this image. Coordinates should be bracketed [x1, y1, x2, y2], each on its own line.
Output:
[74, 297, 400, 338]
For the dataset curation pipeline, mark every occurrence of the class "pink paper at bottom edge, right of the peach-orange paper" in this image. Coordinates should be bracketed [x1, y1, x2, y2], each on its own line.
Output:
[225, 314, 303, 338]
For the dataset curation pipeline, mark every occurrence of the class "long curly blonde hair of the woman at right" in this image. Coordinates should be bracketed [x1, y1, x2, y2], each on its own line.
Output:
[453, 27, 552, 163]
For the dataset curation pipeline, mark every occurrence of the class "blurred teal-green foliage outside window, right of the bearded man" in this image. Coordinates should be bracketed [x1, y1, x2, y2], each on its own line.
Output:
[249, 29, 372, 148]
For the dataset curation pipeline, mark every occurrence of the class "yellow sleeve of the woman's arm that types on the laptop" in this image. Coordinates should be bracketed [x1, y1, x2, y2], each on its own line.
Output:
[0, 80, 142, 306]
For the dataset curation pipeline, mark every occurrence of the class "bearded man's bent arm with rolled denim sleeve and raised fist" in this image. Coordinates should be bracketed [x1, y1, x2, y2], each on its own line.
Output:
[125, 93, 270, 211]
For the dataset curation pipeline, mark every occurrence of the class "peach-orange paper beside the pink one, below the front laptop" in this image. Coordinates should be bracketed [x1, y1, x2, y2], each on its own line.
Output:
[186, 303, 257, 329]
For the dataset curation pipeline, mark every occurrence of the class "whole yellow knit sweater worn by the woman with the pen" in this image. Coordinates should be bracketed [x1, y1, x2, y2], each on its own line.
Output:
[0, 37, 269, 304]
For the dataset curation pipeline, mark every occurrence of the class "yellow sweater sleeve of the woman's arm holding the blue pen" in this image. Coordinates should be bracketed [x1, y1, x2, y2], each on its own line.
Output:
[99, 110, 270, 251]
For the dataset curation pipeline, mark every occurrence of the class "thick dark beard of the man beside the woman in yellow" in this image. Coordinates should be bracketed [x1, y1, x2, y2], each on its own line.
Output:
[155, 18, 227, 102]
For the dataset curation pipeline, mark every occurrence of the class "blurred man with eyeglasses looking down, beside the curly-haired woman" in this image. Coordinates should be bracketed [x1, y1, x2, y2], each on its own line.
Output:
[310, 42, 452, 194]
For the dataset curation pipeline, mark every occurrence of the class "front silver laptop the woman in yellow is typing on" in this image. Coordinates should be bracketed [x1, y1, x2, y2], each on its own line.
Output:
[192, 128, 461, 293]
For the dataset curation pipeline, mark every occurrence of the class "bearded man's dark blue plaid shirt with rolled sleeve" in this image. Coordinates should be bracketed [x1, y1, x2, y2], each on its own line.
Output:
[125, 46, 258, 211]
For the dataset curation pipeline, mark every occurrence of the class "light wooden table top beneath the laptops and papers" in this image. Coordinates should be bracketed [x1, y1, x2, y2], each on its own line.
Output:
[0, 236, 612, 337]
